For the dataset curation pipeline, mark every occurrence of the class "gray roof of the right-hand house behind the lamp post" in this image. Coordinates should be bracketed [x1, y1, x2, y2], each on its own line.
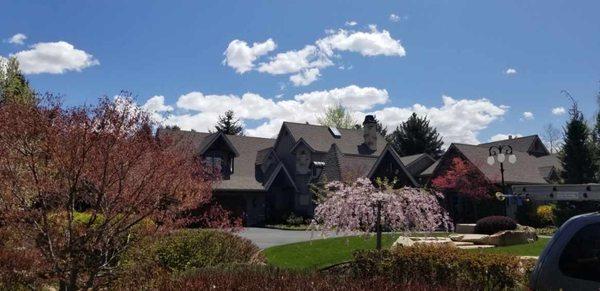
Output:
[418, 135, 561, 190]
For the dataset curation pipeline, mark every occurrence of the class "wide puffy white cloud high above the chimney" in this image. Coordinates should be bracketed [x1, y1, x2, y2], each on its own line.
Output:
[316, 25, 406, 57]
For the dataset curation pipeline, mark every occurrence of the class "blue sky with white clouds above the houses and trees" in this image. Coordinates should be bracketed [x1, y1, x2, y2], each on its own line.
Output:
[0, 0, 600, 144]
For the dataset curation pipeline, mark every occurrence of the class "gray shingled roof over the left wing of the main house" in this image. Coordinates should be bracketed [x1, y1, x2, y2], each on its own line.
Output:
[158, 129, 275, 191]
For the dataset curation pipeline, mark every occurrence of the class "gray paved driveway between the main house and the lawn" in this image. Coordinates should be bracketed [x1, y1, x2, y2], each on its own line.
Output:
[238, 227, 343, 249]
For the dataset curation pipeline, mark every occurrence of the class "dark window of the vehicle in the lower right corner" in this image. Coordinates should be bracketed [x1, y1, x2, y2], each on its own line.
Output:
[558, 223, 600, 282]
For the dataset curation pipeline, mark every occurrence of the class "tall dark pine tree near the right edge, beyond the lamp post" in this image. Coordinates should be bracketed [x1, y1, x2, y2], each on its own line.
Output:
[559, 102, 598, 184]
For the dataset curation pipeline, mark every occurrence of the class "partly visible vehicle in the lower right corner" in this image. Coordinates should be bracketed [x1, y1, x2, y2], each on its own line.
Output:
[530, 212, 600, 290]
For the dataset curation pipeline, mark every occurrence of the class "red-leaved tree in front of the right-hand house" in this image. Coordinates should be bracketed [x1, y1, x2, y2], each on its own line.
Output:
[431, 157, 496, 199]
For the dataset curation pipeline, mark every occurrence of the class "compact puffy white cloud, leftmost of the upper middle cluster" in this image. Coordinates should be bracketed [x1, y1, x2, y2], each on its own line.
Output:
[223, 38, 277, 74]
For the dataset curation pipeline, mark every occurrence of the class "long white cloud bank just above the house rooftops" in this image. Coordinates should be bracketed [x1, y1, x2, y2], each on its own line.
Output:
[156, 85, 508, 144]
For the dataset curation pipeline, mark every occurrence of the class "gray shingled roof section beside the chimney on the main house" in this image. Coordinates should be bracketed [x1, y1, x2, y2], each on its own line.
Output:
[283, 122, 386, 156]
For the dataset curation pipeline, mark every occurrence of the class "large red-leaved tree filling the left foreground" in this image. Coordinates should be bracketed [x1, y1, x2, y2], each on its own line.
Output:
[0, 98, 226, 290]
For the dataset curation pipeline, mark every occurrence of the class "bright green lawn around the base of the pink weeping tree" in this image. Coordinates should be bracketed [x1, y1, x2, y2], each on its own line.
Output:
[264, 234, 550, 270]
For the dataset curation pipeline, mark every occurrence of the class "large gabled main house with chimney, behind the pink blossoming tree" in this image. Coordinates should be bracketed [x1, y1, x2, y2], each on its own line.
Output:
[158, 115, 422, 225]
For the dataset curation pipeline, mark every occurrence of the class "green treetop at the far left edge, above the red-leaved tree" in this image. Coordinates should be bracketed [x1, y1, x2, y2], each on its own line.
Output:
[0, 58, 36, 105]
